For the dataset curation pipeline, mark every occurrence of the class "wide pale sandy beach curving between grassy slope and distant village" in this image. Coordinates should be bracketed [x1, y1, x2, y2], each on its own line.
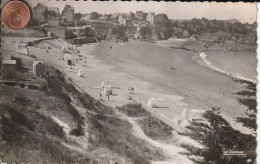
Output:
[2, 36, 254, 133]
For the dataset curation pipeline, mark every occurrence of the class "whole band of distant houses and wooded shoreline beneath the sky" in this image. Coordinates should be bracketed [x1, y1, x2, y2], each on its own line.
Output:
[33, 3, 257, 44]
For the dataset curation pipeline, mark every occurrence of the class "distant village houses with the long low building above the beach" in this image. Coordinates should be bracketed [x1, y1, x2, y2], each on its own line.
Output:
[33, 3, 171, 44]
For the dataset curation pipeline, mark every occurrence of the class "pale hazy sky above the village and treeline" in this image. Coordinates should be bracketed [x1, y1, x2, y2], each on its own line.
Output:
[2, 0, 257, 23]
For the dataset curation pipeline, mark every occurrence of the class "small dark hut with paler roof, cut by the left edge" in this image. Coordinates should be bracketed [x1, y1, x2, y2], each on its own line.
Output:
[1, 60, 16, 80]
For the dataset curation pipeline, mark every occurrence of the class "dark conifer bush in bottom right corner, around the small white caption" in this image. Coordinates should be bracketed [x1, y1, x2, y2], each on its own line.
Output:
[183, 108, 256, 164]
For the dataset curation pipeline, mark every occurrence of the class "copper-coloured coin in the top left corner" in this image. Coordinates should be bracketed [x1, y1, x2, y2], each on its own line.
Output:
[1, 1, 31, 30]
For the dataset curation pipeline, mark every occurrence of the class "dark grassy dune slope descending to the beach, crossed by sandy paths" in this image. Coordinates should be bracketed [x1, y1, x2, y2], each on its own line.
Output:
[0, 52, 169, 164]
